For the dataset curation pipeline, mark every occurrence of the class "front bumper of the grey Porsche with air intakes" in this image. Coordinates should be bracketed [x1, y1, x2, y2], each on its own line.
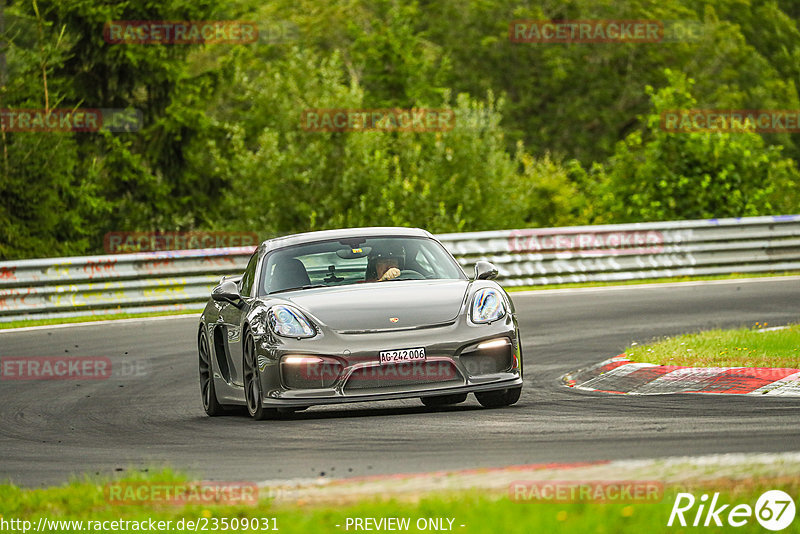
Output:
[256, 315, 522, 407]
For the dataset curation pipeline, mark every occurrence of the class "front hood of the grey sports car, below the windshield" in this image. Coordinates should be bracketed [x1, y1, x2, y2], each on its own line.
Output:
[283, 280, 470, 331]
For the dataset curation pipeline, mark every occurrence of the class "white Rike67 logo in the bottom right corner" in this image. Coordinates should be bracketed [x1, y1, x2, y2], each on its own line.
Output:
[667, 490, 795, 531]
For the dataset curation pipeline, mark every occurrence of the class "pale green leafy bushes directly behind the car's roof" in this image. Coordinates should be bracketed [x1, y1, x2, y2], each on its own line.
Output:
[192, 48, 521, 234]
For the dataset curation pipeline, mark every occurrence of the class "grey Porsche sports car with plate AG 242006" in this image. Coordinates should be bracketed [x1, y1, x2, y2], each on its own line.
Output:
[197, 228, 522, 419]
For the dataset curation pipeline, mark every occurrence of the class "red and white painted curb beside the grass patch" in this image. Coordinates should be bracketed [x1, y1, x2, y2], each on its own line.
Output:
[562, 355, 800, 397]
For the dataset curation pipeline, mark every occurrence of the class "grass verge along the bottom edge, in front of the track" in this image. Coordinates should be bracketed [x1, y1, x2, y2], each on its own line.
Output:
[0, 472, 800, 534]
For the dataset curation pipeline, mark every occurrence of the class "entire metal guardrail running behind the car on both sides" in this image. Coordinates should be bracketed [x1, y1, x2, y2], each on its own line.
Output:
[0, 215, 800, 322]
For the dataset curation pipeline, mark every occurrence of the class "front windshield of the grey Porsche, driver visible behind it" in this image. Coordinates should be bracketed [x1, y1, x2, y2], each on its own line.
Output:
[259, 237, 465, 295]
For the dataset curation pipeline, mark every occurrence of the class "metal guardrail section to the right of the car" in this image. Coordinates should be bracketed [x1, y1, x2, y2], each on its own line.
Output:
[446, 215, 800, 286]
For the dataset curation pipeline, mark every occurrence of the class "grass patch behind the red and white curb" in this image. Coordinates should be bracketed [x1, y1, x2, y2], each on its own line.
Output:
[625, 323, 800, 369]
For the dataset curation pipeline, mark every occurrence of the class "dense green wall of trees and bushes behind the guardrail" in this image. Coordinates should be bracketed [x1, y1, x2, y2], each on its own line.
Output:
[0, 0, 800, 259]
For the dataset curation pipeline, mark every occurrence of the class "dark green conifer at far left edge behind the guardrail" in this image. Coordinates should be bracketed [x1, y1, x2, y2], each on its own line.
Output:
[0, 2, 108, 259]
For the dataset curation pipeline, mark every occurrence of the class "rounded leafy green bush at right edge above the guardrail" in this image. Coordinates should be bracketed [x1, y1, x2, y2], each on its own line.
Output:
[596, 70, 800, 222]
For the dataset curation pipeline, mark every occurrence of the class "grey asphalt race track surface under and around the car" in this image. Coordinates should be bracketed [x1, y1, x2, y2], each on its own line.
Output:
[0, 277, 800, 486]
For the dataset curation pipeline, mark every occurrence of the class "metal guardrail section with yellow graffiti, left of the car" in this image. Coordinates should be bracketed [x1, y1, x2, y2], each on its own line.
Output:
[0, 246, 254, 322]
